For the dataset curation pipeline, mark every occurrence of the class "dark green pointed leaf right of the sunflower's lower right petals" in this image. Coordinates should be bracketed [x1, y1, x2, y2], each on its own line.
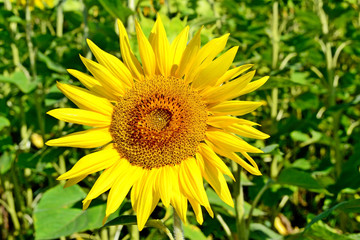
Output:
[277, 168, 323, 189]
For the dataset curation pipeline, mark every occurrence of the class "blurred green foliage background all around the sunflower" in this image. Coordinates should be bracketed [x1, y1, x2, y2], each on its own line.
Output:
[0, 0, 360, 240]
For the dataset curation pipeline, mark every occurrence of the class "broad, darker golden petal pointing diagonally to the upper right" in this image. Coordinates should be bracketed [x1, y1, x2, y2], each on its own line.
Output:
[192, 47, 239, 89]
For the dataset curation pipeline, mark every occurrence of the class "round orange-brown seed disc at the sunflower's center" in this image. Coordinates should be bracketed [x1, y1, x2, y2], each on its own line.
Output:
[110, 76, 207, 169]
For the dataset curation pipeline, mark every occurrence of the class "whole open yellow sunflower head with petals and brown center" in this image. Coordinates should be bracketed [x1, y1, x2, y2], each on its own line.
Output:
[46, 16, 268, 230]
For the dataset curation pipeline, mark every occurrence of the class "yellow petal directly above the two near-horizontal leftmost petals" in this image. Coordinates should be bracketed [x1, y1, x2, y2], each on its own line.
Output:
[57, 82, 113, 116]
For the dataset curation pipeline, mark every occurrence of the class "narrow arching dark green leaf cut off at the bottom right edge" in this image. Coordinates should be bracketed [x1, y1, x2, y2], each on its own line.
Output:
[304, 199, 360, 231]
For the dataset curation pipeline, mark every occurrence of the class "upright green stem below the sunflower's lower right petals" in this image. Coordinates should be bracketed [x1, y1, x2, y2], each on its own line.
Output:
[232, 162, 249, 240]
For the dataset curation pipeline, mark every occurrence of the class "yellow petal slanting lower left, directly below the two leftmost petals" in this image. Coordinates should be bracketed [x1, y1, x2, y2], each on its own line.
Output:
[57, 144, 120, 180]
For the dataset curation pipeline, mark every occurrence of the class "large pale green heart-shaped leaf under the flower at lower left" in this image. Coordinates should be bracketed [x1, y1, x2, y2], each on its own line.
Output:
[34, 185, 106, 239]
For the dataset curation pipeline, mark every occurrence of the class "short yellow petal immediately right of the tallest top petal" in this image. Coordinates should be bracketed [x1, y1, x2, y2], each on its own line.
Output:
[170, 26, 190, 75]
